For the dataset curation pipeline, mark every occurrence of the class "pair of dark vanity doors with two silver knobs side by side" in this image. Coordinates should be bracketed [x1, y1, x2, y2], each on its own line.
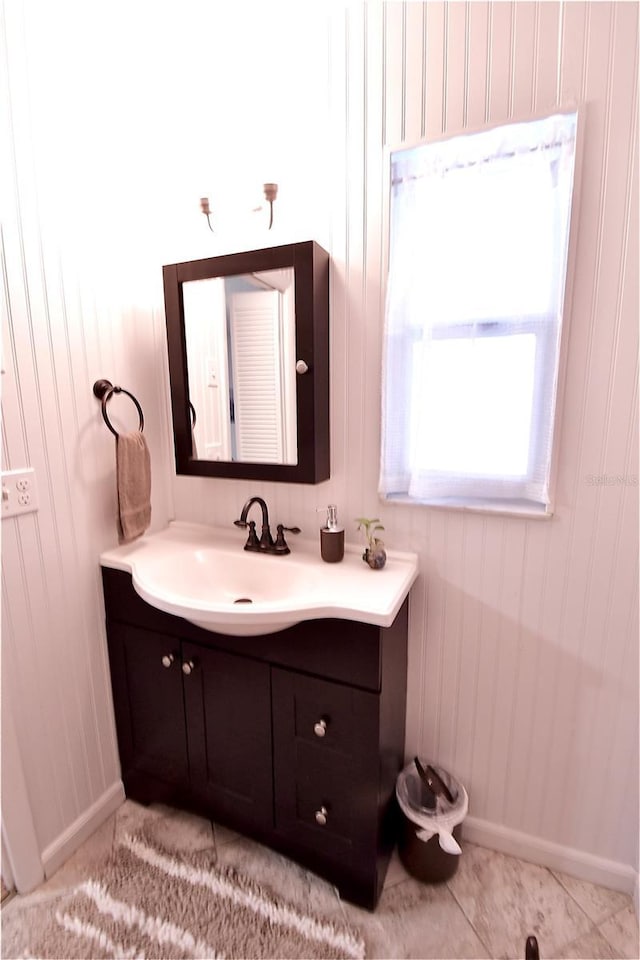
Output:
[109, 621, 272, 829]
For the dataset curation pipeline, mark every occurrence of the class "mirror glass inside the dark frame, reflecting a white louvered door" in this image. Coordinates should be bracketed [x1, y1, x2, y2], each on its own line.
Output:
[183, 268, 297, 464]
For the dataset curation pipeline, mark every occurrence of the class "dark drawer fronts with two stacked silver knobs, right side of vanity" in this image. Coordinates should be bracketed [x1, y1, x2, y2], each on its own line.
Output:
[273, 670, 380, 870]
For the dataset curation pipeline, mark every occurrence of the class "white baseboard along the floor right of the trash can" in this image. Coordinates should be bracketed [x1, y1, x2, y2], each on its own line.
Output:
[462, 817, 638, 896]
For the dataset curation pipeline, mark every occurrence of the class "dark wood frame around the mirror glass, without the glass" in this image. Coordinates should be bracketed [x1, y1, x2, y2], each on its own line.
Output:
[162, 241, 330, 483]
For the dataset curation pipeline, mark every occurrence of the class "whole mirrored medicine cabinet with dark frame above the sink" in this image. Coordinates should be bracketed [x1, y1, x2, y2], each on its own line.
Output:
[163, 241, 329, 483]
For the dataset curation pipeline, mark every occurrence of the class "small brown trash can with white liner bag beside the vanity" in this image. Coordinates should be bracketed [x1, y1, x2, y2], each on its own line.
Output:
[396, 757, 469, 883]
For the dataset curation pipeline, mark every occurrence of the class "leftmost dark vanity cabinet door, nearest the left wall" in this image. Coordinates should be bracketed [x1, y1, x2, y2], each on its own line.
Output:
[109, 623, 189, 792]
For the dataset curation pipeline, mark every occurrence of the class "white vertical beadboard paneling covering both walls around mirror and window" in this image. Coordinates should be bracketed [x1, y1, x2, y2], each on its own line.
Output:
[0, 0, 638, 889]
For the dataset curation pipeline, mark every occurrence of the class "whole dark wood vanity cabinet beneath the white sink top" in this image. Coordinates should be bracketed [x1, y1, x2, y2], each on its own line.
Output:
[102, 567, 407, 909]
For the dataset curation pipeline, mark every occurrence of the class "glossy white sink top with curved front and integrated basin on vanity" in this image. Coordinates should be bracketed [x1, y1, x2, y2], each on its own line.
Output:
[100, 521, 418, 636]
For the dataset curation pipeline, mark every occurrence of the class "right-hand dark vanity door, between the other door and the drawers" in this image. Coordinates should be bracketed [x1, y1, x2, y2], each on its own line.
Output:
[182, 643, 273, 829]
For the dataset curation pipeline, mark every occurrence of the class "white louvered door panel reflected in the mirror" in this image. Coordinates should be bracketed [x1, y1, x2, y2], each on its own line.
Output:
[230, 290, 283, 463]
